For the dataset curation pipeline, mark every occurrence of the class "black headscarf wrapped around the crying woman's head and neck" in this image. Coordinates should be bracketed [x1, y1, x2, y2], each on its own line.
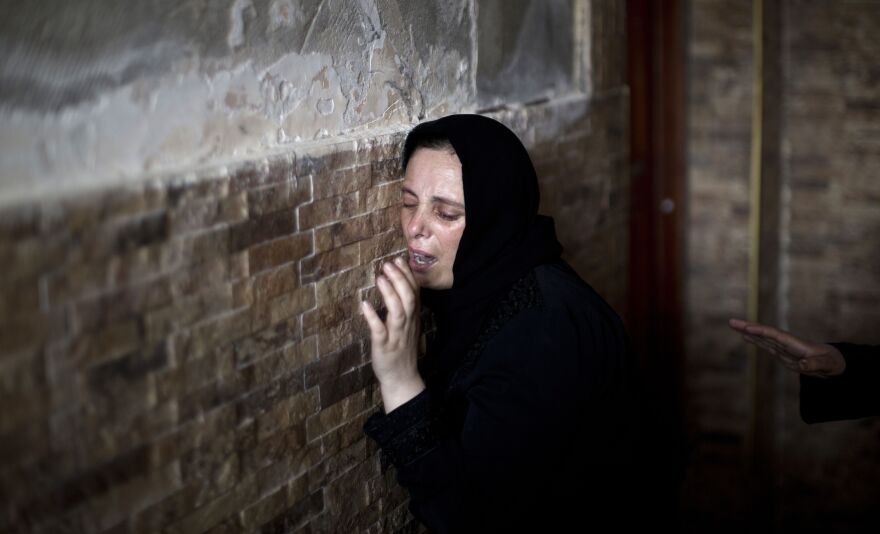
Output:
[403, 115, 562, 386]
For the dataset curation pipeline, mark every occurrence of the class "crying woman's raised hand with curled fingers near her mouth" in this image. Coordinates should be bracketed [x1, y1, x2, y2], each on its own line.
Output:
[361, 258, 425, 413]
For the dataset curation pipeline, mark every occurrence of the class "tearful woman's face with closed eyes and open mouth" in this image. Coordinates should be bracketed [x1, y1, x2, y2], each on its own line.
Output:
[400, 148, 464, 289]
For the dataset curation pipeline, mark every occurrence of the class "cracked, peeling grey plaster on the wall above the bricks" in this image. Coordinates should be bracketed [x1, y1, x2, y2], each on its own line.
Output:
[0, 0, 573, 207]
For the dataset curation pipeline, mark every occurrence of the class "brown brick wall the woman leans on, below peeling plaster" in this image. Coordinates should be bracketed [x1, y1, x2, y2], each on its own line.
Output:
[0, 133, 420, 532]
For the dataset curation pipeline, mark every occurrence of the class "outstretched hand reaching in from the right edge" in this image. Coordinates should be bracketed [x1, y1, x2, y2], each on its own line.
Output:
[729, 319, 846, 377]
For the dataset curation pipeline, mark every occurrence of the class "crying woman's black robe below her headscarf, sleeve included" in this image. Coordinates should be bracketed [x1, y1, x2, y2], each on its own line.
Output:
[365, 263, 636, 532]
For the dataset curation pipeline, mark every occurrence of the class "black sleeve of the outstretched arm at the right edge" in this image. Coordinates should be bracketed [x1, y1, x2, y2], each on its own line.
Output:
[801, 343, 880, 423]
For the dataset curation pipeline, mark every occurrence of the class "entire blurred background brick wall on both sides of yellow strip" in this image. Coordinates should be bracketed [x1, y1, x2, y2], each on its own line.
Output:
[683, 0, 880, 531]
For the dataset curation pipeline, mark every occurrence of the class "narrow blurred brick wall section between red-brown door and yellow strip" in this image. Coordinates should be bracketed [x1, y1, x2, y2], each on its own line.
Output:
[683, 0, 752, 528]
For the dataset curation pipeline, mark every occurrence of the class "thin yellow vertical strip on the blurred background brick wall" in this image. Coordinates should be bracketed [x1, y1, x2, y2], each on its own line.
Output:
[746, 0, 764, 468]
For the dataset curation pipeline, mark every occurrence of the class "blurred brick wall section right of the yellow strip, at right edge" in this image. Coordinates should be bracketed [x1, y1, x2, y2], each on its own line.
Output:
[777, 0, 880, 531]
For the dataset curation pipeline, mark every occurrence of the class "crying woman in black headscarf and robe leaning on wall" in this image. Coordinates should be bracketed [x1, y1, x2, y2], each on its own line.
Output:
[363, 115, 634, 532]
